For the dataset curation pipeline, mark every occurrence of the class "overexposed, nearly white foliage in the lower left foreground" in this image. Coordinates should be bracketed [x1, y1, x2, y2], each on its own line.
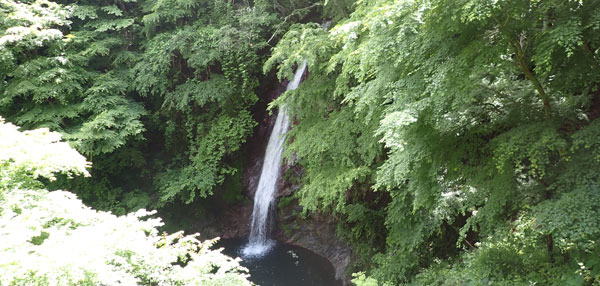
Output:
[0, 116, 251, 285]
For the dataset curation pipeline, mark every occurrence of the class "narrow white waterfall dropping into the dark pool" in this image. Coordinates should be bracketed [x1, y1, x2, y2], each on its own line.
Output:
[242, 62, 306, 256]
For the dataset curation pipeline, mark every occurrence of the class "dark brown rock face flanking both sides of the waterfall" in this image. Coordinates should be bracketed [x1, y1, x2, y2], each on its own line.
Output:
[199, 74, 352, 285]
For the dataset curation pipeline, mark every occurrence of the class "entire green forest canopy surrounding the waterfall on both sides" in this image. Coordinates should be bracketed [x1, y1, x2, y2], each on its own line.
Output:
[0, 0, 600, 285]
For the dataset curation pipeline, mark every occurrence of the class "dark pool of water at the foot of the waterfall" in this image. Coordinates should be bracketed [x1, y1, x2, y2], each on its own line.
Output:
[217, 239, 341, 286]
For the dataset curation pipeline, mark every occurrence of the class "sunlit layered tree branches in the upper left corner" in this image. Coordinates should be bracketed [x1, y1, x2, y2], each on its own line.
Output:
[0, 1, 144, 155]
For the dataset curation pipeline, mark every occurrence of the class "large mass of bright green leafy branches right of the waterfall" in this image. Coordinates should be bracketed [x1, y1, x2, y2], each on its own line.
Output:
[265, 0, 600, 285]
